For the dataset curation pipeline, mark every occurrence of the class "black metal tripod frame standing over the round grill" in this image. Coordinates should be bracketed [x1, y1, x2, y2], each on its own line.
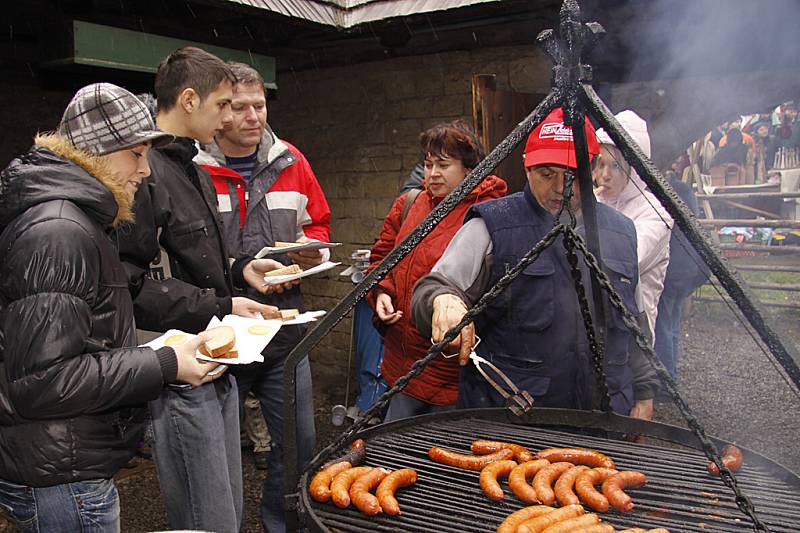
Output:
[284, 0, 800, 526]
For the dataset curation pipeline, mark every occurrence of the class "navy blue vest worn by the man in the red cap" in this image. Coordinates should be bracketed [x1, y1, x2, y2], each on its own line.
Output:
[466, 186, 638, 414]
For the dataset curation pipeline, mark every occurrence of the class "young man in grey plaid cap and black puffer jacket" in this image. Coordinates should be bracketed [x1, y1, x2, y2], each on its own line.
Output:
[0, 83, 217, 532]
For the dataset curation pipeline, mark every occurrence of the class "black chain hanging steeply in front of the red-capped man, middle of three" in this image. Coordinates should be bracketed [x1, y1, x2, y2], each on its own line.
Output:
[556, 171, 611, 411]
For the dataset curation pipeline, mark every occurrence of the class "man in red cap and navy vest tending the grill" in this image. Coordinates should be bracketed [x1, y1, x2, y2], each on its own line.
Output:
[412, 108, 658, 418]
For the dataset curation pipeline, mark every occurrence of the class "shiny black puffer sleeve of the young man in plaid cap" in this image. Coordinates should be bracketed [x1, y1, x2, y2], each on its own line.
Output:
[1, 219, 164, 419]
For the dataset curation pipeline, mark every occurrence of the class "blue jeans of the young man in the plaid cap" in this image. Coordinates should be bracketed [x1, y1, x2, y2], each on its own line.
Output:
[0, 479, 120, 533]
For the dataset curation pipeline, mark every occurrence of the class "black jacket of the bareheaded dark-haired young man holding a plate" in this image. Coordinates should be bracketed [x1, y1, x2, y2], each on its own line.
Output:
[116, 137, 233, 333]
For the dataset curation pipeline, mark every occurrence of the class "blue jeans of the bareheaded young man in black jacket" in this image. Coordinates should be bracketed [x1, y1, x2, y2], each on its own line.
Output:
[150, 371, 244, 533]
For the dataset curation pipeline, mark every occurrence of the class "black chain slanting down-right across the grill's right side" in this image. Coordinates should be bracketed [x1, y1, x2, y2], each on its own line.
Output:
[564, 228, 769, 532]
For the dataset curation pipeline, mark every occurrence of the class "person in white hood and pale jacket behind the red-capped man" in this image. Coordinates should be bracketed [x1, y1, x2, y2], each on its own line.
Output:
[592, 111, 672, 338]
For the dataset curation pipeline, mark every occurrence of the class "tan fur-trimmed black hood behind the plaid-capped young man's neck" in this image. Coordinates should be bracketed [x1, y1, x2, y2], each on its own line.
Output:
[0, 133, 133, 229]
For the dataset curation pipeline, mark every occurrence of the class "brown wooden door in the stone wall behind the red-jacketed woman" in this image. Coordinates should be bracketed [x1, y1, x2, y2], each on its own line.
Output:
[472, 74, 547, 194]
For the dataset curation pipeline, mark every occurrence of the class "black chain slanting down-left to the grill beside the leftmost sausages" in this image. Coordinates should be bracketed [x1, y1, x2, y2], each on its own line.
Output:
[301, 225, 564, 476]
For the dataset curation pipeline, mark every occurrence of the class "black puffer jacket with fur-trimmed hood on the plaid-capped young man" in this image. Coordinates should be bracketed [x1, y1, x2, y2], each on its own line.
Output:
[0, 136, 177, 487]
